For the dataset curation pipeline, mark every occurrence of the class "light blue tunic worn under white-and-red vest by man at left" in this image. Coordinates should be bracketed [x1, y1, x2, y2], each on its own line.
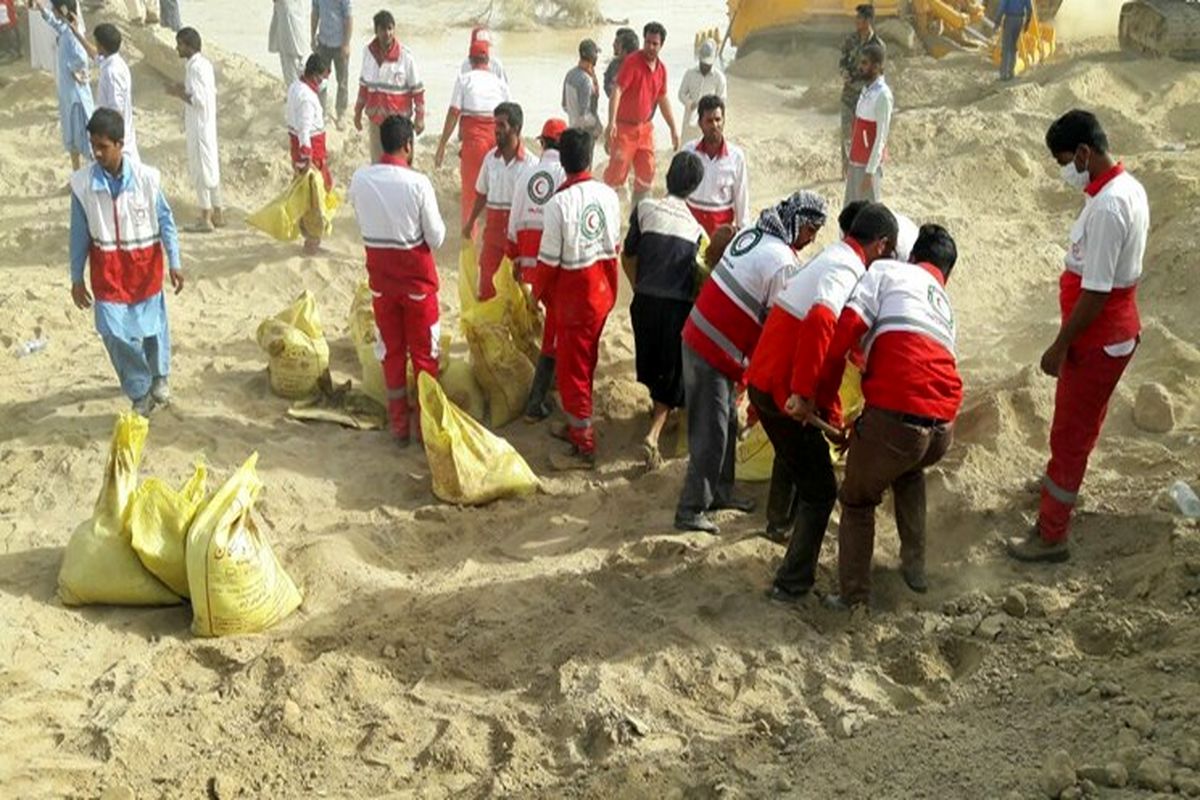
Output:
[71, 158, 180, 339]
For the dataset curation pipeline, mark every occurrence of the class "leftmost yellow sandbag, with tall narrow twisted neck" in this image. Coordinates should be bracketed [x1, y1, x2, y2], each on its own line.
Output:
[59, 411, 180, 606]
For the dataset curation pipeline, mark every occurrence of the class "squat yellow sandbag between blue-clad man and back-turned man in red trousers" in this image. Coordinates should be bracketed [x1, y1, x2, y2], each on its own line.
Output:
[258, 289, 329, 399]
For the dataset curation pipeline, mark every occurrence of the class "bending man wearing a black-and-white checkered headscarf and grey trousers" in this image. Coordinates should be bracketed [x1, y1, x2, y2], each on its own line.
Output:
[674, 192, 827, 534]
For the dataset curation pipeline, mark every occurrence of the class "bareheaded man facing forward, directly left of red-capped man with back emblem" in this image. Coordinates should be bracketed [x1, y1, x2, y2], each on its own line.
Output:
[462, 103, 530, 300]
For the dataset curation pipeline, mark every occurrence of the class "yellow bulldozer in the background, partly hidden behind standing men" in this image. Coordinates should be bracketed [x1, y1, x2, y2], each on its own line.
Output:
[726, 0, 1060, 72]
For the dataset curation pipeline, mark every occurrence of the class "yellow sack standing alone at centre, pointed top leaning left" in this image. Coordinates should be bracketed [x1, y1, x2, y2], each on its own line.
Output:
[418, 373, 538, 505]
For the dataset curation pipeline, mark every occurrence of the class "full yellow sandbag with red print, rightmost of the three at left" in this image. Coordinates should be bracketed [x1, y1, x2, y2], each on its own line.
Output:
[187, 453, 301, 636]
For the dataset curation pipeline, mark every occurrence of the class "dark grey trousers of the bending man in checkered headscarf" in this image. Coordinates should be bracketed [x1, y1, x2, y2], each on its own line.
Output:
[676, 343, 738, 517]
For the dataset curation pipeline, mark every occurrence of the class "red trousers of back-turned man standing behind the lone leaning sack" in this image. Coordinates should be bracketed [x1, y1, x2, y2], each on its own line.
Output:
[372, 293, 438, 439]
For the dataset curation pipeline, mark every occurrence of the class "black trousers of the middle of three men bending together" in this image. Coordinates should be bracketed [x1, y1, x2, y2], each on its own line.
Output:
[750, 386, 838, 593]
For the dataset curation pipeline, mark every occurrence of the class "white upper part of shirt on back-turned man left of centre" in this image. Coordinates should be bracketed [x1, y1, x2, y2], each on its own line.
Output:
[347, 163, 446, 249]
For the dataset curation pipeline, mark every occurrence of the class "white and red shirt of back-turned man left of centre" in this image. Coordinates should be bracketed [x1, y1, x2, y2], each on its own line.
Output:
[348, 155, 446, 300]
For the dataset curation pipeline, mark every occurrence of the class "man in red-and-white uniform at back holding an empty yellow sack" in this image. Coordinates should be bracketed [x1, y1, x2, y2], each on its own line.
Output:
[284, 53, 334, 255]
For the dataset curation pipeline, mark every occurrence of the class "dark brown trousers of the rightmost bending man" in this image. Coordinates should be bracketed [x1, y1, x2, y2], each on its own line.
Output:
[838, 407, 954, 603]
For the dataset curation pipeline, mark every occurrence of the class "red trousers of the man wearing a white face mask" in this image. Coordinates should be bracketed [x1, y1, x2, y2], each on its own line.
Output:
[1038, 347, 1133, 542]
